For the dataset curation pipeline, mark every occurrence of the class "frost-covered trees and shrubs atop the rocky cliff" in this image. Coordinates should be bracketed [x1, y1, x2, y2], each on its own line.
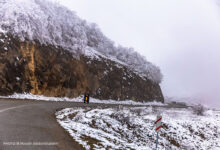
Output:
[0, 0, 162, 83]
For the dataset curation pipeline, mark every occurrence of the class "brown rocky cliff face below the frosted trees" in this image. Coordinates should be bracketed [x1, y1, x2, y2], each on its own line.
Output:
[0, 34, 164, 102]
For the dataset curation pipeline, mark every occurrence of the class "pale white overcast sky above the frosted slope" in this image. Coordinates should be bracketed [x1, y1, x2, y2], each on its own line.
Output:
[52, 0, 220, 107]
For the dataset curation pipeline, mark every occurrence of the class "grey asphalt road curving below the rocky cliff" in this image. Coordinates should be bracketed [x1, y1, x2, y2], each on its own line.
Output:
[0, 99, 188, 150]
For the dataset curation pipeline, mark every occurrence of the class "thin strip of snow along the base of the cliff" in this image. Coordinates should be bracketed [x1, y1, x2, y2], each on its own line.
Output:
[0, 93, 167, 106]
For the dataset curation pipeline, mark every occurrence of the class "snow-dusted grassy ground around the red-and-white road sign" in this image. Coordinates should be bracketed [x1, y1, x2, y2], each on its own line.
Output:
[56, 107, 220, 150]
